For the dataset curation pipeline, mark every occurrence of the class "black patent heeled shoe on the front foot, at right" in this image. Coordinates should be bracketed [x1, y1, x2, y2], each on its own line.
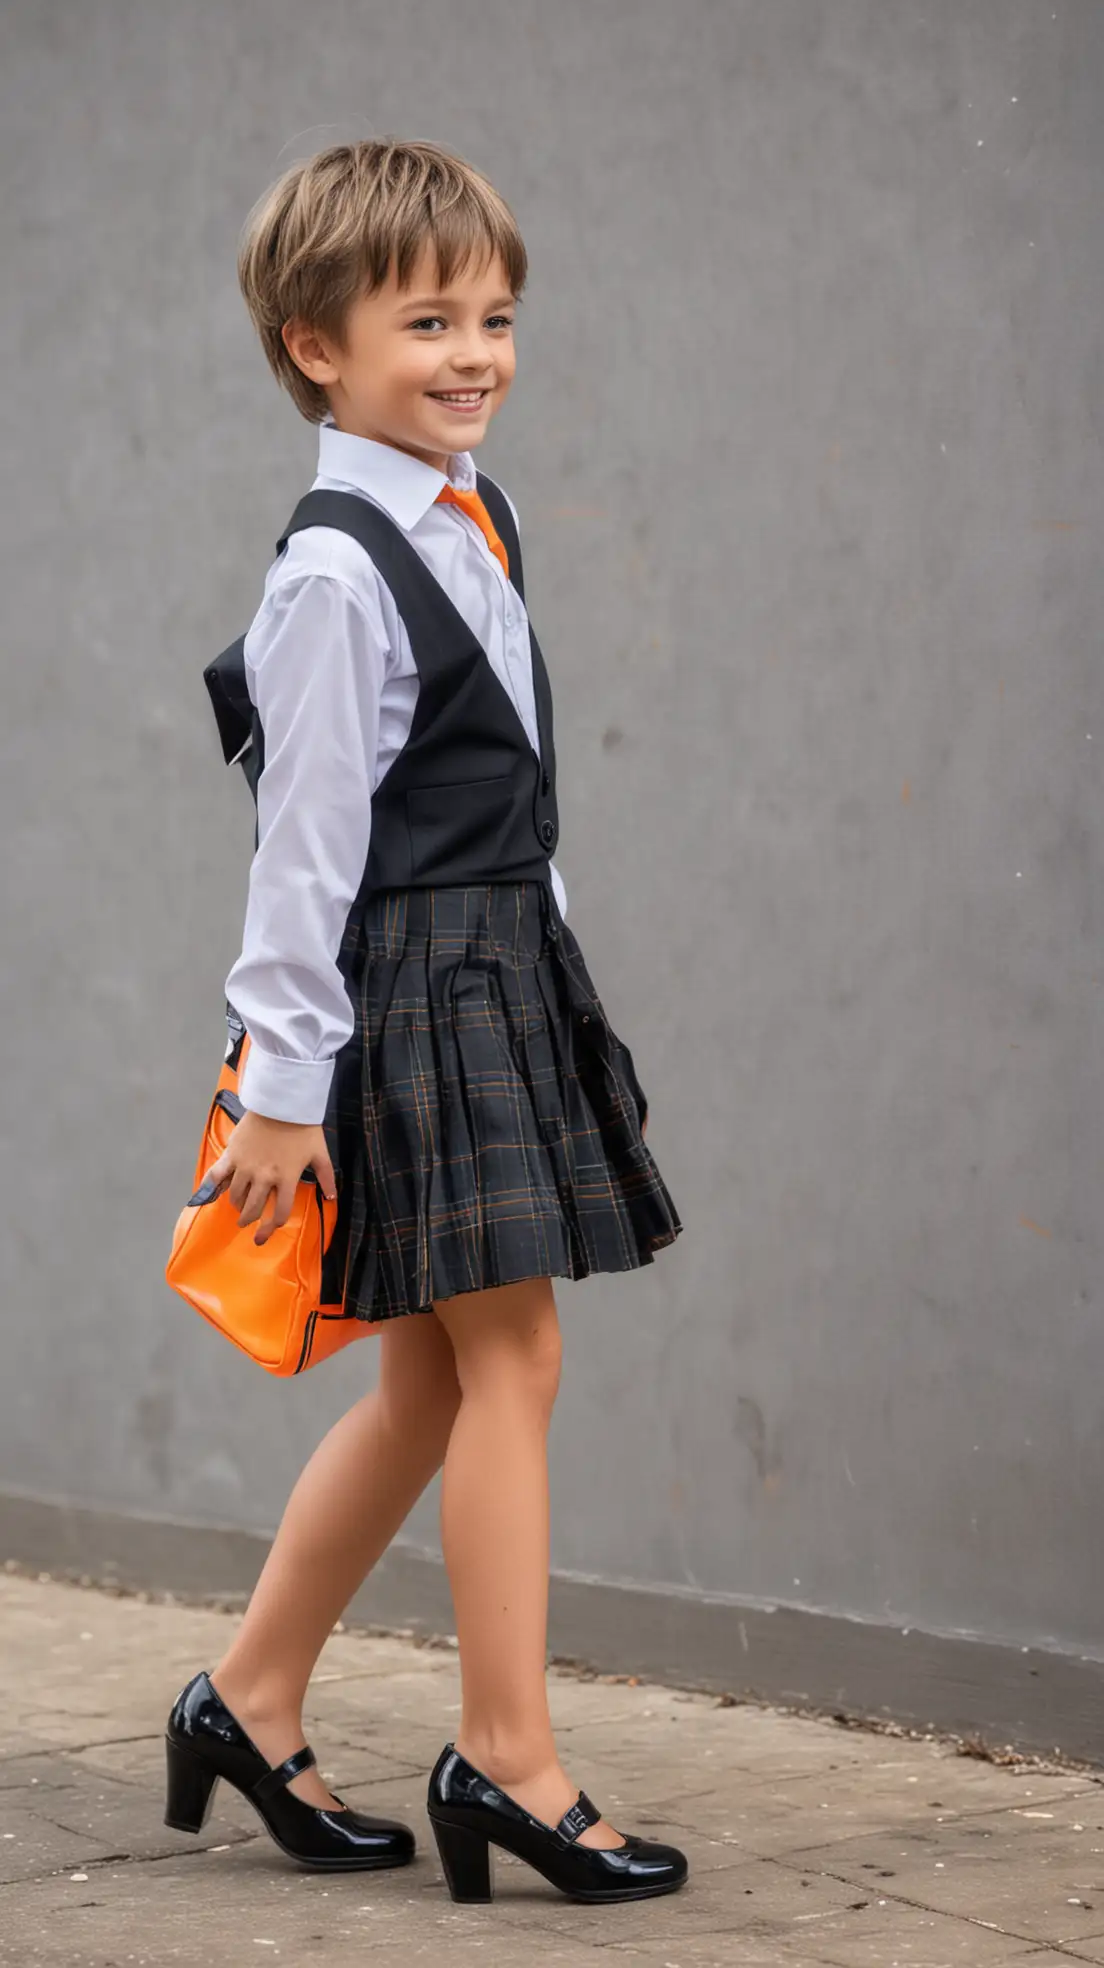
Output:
[427, 1742, 689, 1901]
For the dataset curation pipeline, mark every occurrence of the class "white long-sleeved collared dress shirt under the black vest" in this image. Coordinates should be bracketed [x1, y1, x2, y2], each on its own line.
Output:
[226, 421, 567, 1122]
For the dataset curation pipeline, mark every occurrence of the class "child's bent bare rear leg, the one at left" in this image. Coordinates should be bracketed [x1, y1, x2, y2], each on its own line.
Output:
[211, 1313, 460, 1807]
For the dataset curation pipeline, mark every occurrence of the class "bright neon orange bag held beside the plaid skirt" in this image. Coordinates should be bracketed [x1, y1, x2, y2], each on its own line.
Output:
[165, 1031, 380, 1374]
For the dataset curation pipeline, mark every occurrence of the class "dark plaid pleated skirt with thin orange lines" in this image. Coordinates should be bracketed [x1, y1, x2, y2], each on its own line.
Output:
[335, 882, 683, 1322]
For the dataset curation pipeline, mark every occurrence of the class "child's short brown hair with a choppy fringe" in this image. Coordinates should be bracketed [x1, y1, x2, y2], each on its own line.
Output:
[238, 136, 527, 423]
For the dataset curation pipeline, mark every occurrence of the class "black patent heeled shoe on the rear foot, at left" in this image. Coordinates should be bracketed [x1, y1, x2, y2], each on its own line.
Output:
[165, 1673, 415, 1872]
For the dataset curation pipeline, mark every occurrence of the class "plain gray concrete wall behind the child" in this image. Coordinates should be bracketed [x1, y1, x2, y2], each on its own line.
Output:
[0, 0, 1104, 1692]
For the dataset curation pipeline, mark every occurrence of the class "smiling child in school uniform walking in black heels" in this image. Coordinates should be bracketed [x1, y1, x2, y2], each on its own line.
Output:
[165, 138, 687, 1901]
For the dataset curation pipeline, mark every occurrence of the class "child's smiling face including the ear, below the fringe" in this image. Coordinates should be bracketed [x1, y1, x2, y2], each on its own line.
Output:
[283, 244, 516, 472]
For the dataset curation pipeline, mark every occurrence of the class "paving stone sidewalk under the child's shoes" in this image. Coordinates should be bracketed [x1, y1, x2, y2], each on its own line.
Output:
[0, 1570, 1104, 1968]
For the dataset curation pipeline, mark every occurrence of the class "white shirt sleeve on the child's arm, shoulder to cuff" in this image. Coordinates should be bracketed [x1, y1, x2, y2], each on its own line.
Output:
[226, 573, 388, 1124]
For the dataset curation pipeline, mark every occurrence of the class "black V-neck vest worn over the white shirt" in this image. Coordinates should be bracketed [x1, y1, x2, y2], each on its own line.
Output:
[205, 472, 559, 905]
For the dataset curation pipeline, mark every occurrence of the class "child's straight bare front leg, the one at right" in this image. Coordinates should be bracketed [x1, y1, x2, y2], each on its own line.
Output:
[433, 1277, 624, 1846]
